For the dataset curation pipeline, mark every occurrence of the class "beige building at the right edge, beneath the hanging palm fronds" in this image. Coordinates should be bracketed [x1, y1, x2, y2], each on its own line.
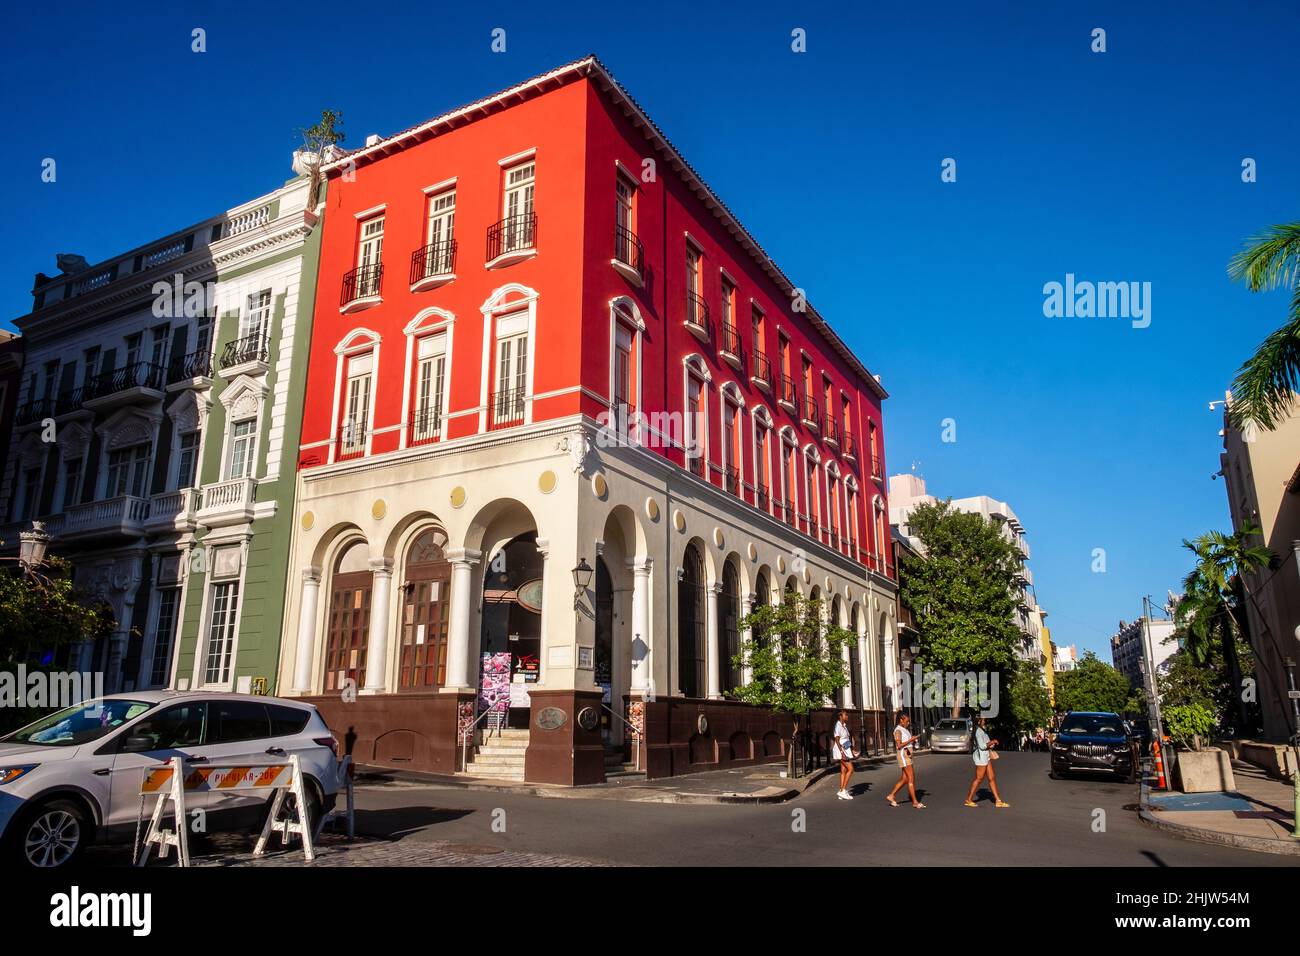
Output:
[1219, 394, 1300, 740]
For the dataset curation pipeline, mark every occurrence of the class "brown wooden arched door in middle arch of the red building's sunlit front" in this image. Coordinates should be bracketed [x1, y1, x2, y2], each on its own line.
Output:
[398, 528, 451, 691]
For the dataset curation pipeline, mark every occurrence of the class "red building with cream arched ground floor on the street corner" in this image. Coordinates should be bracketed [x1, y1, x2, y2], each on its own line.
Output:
[281, 57, 896, 782]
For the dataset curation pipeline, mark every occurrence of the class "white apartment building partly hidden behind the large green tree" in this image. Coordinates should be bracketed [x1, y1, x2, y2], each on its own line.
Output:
[889, 475, 1052, 687]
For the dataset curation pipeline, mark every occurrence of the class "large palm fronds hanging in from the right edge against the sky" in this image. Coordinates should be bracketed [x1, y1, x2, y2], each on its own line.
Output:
[1227, 222, 1300, 432]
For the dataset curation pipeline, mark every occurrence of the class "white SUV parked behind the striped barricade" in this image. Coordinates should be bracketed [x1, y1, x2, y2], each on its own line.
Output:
[0, 691, 343, 868]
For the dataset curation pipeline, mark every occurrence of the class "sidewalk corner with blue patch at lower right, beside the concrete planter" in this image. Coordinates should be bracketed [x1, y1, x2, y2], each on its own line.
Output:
[1139, 761, 1300, 856]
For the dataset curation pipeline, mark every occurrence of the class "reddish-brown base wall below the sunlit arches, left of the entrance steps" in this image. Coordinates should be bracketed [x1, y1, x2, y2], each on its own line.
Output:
[303, 693, 473, 774]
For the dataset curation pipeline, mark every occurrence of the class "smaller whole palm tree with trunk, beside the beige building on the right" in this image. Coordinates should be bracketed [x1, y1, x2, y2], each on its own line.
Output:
[1174, 524, 1274, 726]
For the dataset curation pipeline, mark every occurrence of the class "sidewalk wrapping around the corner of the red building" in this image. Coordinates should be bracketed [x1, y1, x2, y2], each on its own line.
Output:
[356, 750, 909, 804]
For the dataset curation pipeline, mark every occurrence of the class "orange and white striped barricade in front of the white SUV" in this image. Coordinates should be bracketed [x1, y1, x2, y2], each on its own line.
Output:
[135, 753, 316, 866]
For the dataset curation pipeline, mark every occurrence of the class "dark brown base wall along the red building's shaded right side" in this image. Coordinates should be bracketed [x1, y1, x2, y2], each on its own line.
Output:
[641, 697, 887, 779]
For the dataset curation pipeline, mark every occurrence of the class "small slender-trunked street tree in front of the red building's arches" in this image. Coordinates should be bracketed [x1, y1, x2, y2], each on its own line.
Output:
[732, 591, 858, 775]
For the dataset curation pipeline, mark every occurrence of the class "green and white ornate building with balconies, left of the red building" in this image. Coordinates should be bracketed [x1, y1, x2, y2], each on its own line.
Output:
[0, 164, 316, 692]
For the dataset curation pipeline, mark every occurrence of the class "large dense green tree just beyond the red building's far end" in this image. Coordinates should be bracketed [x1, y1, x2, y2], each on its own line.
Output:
[898, 501, 1023, 713]
